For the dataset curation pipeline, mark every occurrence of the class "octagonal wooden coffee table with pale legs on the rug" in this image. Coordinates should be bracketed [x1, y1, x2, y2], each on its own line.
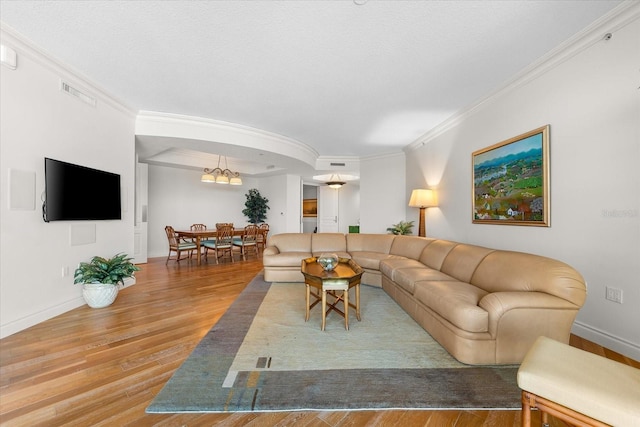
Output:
[301, 257, 364, 331]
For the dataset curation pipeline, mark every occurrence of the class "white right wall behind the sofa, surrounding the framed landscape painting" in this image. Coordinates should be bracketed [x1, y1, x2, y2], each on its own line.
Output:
[407, 12, 640, 360]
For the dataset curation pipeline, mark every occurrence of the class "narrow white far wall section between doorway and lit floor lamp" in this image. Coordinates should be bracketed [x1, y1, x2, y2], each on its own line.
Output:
[360, 153, 404, 234]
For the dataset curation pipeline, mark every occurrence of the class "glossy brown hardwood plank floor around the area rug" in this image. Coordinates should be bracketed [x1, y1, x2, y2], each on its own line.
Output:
[0, 256, 640, 427]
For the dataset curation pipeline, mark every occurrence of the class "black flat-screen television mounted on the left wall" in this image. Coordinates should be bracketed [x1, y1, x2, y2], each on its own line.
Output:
[43, 157, 122, 222]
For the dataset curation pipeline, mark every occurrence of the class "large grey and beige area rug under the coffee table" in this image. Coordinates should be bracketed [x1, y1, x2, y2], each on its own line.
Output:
[147, 274, 520, 413]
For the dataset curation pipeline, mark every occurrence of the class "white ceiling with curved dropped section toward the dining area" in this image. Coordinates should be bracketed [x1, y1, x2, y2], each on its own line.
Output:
[0, 0, 621, 182]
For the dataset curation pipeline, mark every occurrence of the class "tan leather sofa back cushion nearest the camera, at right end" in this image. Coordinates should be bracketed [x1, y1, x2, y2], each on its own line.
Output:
[471, 251, 587, 306]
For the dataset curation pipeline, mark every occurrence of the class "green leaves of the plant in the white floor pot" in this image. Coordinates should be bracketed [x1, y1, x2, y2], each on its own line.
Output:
[73, 253, 140, 285]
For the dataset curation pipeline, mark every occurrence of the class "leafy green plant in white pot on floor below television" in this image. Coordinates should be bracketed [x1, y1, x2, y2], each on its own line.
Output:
[73, 253, 140, 308]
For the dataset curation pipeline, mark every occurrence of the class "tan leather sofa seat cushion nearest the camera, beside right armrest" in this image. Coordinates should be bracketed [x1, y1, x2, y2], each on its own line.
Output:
[413, 281, 489, 332]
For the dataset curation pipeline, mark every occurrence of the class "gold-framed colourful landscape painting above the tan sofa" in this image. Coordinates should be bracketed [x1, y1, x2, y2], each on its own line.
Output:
[472, 125, 549, 227]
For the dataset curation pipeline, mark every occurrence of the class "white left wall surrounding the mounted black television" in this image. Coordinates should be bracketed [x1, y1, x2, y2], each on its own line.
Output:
[0, 29, 134, 337]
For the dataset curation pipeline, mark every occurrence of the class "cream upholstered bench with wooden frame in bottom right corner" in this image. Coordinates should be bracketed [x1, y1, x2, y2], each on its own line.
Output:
[518, 337, 640, 427]
